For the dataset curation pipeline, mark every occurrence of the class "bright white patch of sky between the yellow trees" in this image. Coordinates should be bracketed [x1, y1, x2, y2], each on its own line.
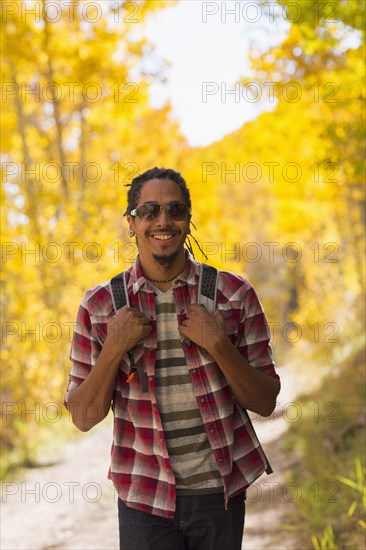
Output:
[146, 0, 289, 146]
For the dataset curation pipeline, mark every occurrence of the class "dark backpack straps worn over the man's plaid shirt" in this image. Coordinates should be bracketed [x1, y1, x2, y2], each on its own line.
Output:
[110, 263, 273, 475]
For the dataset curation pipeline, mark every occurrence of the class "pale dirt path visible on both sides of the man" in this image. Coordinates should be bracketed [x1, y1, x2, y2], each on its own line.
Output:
[0, 367, 305, 550]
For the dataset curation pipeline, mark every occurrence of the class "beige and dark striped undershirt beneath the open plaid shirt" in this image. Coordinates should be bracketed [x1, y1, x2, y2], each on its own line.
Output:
[154, 287, 224, 495]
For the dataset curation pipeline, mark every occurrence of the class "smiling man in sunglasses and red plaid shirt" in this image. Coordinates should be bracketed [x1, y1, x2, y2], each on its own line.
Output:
[66, 168, 280, 550]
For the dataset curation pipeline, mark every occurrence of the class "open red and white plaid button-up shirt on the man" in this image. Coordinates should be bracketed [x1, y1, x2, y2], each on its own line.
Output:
[66, 251, 279, 519]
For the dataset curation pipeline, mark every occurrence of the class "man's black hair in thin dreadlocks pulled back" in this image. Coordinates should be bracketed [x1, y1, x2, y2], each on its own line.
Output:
[124, 166, 207, 260]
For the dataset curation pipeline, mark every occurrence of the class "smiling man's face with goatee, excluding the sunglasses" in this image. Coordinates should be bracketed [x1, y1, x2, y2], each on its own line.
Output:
[127, 179, 189, 267]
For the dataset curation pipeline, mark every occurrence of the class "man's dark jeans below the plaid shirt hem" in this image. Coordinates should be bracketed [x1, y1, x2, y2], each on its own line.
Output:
[118, 493, 245, 550]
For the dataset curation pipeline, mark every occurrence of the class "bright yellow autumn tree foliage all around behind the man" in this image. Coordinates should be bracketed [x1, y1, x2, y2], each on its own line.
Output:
[1, 0, 365, 508]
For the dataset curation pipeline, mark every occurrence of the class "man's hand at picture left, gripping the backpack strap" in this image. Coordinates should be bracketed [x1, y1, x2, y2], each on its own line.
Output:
[104, 307, 151, 359]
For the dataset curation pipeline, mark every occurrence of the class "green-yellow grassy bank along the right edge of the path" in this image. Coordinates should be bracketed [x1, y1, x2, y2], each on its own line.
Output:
[285, 350, 366, 550]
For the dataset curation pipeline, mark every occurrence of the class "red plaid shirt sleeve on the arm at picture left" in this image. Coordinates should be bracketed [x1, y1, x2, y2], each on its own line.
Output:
[65, 292, 102, 404]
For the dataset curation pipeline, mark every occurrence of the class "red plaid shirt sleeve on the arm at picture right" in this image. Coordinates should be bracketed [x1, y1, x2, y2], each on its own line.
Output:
[237, 283, 280, 384]
